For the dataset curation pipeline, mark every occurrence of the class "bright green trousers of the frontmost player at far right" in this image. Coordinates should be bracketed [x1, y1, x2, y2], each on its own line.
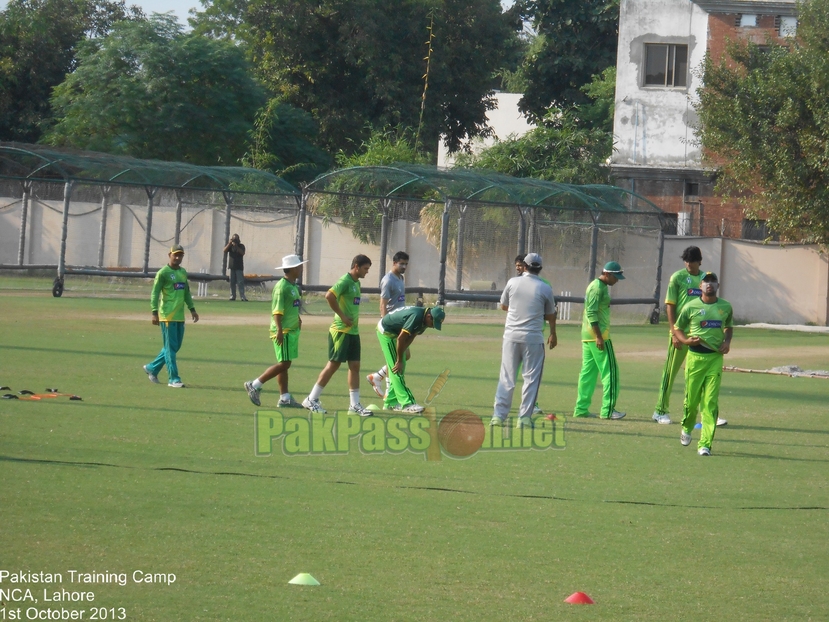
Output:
[682, 350, 723, 449]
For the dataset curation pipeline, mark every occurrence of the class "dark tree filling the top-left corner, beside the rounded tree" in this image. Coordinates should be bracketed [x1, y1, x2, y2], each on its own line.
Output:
[0, 0, 143, 142]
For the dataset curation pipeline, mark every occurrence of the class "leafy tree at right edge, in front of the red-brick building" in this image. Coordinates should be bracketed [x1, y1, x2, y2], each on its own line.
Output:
[697, 0, 829, 245]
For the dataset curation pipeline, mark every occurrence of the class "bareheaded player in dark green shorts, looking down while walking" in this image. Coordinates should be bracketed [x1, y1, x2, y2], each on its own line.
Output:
[302, 255, 373, 417]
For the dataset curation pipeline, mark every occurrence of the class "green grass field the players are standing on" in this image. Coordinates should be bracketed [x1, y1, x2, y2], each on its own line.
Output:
[0, 290, 829, 621]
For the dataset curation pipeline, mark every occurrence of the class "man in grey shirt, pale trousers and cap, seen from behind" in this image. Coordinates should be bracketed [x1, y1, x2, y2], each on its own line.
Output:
[490, 253, 558, 427]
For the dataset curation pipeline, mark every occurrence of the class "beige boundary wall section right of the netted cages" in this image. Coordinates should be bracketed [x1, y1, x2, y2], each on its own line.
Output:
[662, 236, 829, 326]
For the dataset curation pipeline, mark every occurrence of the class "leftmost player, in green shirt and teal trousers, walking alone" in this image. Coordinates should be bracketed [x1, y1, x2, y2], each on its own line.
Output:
[144, 244, 199, 389]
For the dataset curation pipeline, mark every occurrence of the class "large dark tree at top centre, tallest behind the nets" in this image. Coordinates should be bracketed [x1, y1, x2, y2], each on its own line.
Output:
[231, 0, 515, 158]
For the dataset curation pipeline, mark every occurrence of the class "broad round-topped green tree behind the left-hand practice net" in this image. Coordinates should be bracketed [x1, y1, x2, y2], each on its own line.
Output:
[46, 14, 265, 165]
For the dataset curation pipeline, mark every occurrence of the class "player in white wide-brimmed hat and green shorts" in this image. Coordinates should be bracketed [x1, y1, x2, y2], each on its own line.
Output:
[245, 255, 307, 408]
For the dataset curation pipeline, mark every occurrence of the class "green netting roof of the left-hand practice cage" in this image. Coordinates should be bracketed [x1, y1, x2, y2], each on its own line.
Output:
[0, 143, 300, 196]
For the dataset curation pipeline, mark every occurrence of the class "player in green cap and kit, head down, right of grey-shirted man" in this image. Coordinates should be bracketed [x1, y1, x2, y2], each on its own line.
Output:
[573, 261, 625, 419]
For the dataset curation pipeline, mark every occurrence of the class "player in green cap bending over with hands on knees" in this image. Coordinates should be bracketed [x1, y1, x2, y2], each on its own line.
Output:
[377, 307, 446, 413]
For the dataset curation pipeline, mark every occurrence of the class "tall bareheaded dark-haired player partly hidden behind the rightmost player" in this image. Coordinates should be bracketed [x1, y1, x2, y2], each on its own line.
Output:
[653, 246, 728, 425]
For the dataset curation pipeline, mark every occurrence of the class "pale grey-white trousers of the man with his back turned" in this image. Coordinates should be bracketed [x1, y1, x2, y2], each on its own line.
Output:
[495, 339, 544, 419]
